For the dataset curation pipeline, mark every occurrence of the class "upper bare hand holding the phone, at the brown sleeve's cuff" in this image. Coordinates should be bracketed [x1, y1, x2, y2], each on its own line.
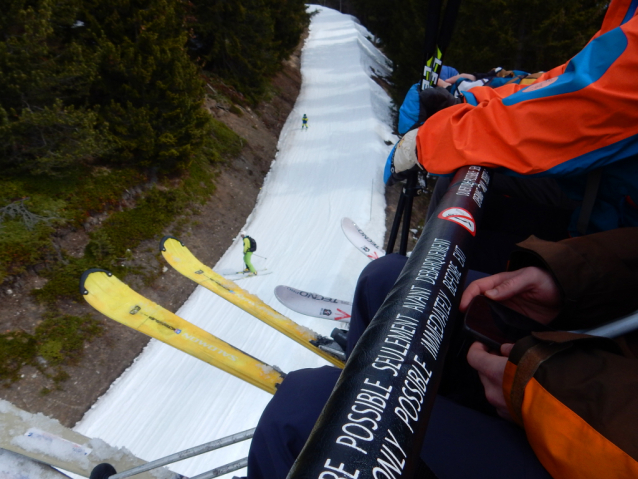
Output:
[459, 266, 563, 324]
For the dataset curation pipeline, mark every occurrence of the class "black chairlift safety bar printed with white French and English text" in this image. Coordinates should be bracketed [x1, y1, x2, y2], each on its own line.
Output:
[288, 166, 490, 479]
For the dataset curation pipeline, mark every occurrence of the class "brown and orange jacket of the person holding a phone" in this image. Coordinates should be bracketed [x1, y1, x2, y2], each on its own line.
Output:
[503, 228, 638, 479]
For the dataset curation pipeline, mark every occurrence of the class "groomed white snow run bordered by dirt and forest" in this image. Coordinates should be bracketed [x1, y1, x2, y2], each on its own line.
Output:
[75, 5, 396, 477]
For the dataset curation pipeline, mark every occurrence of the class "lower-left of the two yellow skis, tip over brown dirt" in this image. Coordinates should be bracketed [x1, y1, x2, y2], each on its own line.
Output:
[80, 269, 284, 394]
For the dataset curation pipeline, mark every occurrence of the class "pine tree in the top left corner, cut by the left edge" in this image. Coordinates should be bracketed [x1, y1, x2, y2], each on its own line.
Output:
[0, 0, 104, 174]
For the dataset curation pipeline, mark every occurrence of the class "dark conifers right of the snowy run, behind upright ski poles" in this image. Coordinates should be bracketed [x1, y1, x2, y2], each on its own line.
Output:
[350, 0, 608, 104]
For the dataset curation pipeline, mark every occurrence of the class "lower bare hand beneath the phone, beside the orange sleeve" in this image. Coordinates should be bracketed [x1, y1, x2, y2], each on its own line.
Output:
[467, 341, 514, 421]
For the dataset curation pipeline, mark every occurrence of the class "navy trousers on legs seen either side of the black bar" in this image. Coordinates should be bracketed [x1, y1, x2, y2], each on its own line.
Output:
[248, 254, 550, 479]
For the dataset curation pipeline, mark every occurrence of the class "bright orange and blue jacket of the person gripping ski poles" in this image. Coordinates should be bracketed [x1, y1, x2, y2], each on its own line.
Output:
[417, 0, 638, 233]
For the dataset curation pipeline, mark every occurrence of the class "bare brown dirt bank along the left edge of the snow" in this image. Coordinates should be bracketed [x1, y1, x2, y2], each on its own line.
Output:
[0, 39, 303, 427]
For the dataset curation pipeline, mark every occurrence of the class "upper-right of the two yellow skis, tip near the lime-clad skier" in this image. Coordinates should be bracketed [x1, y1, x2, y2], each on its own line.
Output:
[160, 236, 344, 368]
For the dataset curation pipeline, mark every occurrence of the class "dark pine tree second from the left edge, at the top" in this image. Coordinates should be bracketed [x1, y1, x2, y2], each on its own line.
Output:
[82, 0, 210, 171]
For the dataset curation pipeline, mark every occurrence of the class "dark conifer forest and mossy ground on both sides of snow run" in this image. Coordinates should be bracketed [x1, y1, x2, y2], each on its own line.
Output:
[0, 0, 607, 402]
